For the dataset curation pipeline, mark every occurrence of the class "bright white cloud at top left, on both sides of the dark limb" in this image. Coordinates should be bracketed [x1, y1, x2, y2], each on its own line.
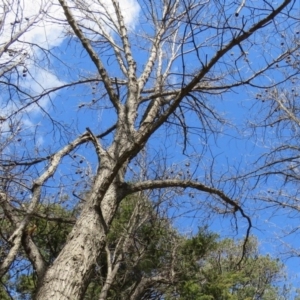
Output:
[0, 0, 140, 120]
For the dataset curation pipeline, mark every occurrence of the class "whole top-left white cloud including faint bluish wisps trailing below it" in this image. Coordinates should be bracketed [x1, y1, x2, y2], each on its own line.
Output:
[0, 0, 140, 151]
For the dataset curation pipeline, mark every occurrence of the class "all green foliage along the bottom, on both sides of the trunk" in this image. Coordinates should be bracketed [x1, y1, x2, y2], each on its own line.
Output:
[0, 196, 290, 300]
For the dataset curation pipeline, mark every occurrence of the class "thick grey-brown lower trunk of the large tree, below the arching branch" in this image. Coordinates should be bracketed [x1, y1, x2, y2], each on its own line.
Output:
[35, 179, 120, 300]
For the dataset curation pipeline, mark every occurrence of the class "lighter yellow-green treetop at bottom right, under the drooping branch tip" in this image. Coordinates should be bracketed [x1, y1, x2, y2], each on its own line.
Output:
[172, 238, 283, 300]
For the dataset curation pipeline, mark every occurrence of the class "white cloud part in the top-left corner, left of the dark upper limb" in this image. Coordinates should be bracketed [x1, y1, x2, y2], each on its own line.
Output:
[0, 0, 64, 114]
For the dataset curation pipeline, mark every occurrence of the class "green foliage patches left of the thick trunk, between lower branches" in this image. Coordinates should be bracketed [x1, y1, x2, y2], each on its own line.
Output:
[0, 204, 75, 300]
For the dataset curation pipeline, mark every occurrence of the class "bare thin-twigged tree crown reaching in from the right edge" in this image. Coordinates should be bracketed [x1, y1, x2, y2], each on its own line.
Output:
[244, 56, 300, 257]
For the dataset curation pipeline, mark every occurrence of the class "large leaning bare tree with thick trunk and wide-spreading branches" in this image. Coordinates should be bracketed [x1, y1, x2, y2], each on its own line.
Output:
[0, 0, 299, 299]
